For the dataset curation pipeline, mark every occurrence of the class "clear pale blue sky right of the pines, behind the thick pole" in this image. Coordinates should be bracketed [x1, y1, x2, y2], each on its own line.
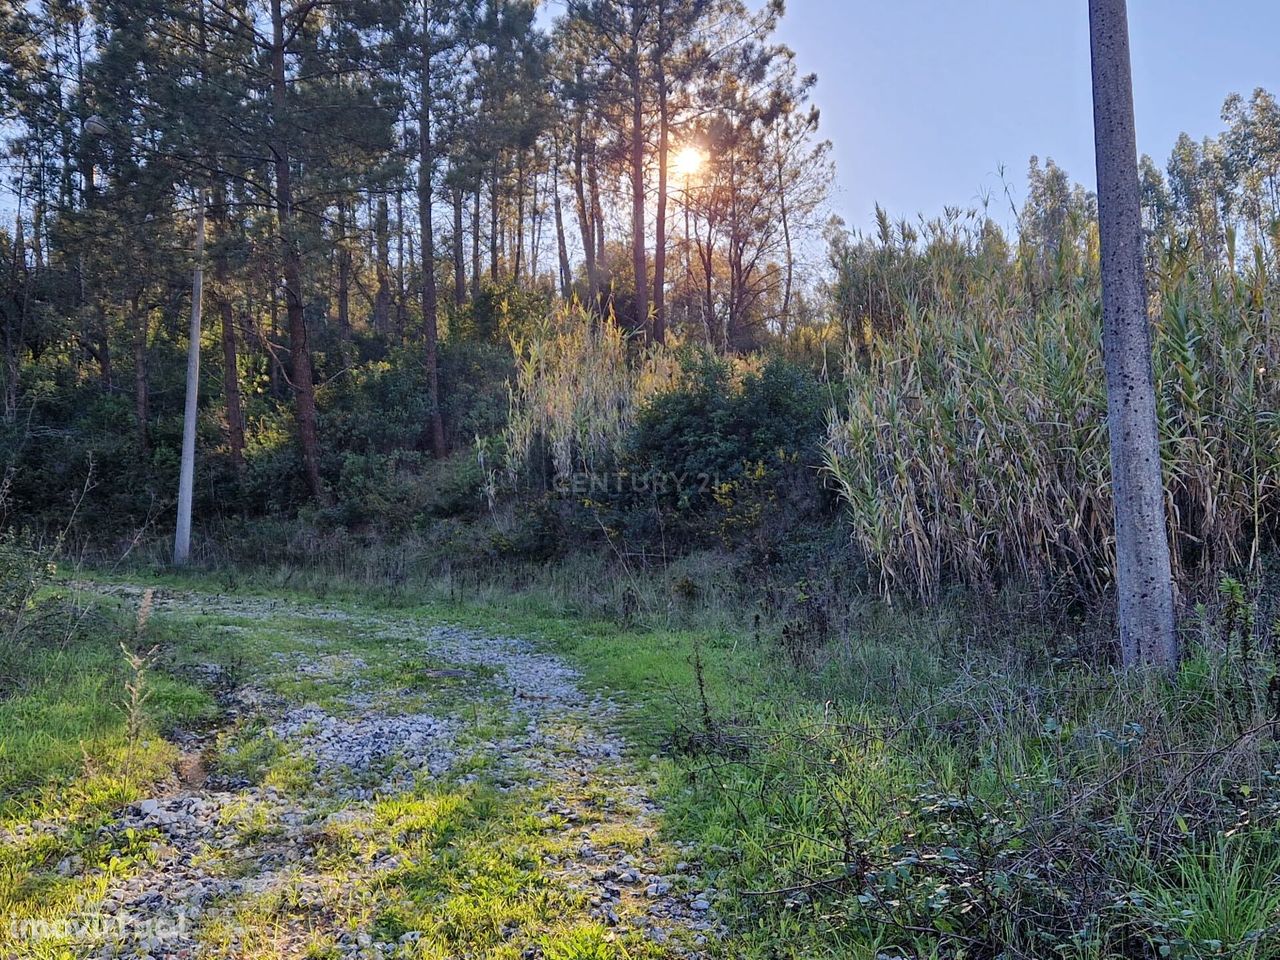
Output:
[781, 0, 1280, 228]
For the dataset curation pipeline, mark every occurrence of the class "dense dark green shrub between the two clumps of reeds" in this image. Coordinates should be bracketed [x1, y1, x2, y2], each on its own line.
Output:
[537, 352, 831, 555]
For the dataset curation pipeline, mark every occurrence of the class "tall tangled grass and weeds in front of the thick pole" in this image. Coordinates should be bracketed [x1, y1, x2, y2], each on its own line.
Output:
[677, 584, 1280, 960]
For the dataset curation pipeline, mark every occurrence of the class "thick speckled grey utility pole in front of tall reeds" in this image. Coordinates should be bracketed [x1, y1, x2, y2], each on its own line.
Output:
[1089, 0, 1178, 672]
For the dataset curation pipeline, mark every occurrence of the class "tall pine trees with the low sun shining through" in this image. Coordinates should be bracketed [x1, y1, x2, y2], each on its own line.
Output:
[0, 0, 831, 502]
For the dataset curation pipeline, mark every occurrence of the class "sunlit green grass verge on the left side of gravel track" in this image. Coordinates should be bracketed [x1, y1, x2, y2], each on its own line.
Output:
[0, 591, 214, 959]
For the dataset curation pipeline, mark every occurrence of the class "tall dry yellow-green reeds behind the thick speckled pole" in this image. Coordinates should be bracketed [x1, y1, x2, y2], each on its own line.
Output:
[826, 248, 1280, 609]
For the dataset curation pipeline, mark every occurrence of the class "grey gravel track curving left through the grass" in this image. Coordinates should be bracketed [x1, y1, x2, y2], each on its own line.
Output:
[60, 588, 722, 960]
